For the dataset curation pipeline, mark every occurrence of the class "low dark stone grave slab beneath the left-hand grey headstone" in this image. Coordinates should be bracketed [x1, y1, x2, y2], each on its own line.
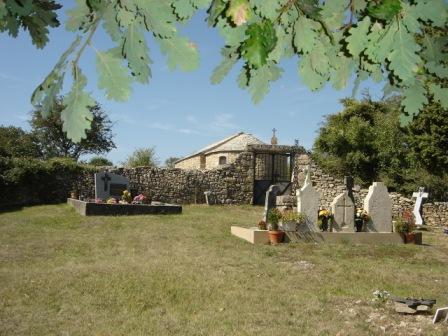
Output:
[67, 198, 182, 216]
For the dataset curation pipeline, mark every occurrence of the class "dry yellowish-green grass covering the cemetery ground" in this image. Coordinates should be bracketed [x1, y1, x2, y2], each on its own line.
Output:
[0, 205, 448, 335]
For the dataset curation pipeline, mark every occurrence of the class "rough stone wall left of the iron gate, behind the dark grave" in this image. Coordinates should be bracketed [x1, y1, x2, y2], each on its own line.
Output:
[74, 152, 253, 204]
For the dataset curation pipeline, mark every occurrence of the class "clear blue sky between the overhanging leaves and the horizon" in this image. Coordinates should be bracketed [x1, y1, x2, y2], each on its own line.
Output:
[0, 1, 381, 164]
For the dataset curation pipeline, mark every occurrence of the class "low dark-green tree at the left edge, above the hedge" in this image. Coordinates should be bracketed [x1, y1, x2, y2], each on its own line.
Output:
[0, 126, 42, 158]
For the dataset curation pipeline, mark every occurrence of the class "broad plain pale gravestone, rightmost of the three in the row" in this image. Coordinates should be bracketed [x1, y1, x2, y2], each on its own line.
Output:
[364, 182, 392, 232]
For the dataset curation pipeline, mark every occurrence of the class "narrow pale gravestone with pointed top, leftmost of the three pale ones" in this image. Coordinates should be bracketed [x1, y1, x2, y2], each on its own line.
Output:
[296, 168, 319, 231]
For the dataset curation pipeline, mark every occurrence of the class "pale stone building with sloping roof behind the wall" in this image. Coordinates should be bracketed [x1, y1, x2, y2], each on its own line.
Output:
[175, 132, 264, 170]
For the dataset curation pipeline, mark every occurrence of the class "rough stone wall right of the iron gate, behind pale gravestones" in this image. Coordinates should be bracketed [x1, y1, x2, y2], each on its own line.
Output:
[292, 154, 448, 226]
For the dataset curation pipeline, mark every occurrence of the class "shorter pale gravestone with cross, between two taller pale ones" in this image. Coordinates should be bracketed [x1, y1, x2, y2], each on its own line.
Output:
[331, 191, 355, 232]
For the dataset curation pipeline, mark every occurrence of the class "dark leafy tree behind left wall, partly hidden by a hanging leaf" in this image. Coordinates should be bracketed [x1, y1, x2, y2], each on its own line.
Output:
[30, 99, 115, 160]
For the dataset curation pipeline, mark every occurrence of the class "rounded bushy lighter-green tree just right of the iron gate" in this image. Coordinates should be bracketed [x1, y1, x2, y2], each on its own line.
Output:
[313, 98, 405, 185]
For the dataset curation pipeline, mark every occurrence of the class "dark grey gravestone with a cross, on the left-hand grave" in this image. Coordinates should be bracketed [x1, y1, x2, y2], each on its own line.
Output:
[95, 172, 129, 199]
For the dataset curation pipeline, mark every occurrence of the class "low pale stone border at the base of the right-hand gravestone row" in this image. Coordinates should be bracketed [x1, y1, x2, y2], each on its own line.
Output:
[230, 226, 422, 245]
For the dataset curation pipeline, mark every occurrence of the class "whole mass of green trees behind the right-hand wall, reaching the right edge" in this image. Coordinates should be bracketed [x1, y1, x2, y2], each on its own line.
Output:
[313, 96, 448, 200]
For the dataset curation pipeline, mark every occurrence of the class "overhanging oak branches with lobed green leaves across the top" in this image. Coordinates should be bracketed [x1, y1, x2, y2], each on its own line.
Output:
[0, 0, 448, 142]
